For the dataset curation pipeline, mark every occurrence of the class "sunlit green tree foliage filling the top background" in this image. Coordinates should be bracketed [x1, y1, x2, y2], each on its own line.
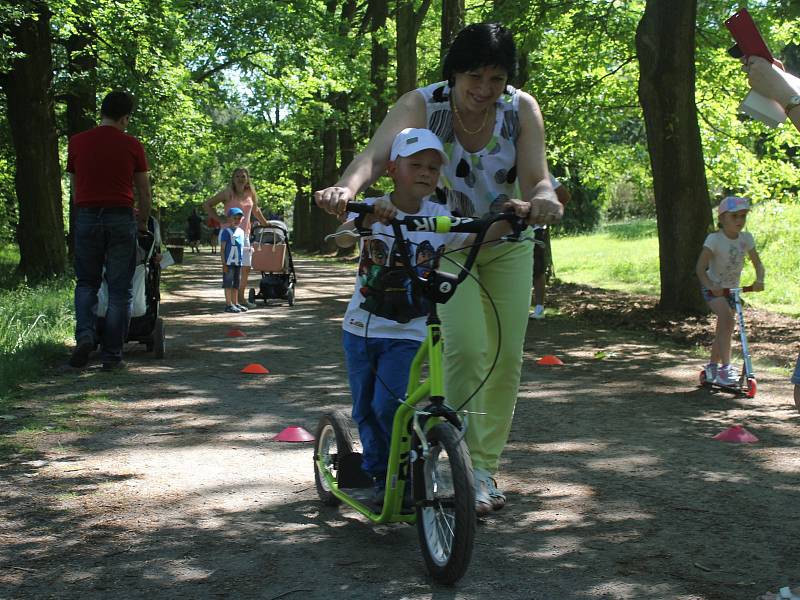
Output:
[0, 0, 800, 304]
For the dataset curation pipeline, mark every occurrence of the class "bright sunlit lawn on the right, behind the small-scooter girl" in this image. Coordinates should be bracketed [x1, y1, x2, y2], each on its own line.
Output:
[552, 203, 800, 317]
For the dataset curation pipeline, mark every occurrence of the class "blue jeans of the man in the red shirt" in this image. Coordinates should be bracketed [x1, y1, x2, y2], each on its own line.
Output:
[75, 207, 136, 363]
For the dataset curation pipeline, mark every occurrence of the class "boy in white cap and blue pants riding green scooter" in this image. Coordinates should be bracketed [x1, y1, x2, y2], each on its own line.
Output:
[339, 129, 467, 505]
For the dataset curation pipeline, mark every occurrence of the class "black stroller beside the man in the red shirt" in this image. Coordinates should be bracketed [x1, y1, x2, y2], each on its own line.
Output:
[97, 217, 166, 358]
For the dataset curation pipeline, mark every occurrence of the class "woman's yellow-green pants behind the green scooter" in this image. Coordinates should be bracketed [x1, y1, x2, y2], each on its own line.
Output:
[439, 241, 533, 473]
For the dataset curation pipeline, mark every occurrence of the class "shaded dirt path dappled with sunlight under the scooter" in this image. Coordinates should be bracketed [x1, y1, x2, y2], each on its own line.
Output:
[0, 255, 800, 600]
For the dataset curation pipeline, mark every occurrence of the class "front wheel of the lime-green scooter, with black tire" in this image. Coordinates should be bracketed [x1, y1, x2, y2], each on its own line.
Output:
[413, 423, 476, 584]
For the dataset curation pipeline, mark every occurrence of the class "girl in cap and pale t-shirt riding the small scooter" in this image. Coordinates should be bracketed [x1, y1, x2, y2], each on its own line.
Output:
[696, 196, 764, 386]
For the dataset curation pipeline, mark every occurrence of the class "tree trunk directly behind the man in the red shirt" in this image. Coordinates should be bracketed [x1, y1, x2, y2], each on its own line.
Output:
[65, 24, 97, 256]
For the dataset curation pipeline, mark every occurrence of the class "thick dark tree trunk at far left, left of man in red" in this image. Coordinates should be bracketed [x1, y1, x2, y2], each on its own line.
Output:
[0, 2, 66, 281]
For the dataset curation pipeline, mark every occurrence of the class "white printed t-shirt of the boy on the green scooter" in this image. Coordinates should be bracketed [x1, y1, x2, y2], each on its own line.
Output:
[342, 195, 469, 341]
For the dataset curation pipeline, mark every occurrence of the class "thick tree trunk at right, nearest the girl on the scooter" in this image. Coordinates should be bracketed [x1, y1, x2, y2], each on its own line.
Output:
[636, 0, 711, 313]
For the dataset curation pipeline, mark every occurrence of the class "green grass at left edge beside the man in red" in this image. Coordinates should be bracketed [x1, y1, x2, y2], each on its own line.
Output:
[0, 246, 74, 407]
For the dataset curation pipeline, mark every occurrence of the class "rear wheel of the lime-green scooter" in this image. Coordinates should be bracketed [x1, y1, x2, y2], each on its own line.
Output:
[314, 411, 353, 506]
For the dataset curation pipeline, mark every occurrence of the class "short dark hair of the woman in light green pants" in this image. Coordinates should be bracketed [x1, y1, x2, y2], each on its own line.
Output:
[442, 23, 517, 87]
